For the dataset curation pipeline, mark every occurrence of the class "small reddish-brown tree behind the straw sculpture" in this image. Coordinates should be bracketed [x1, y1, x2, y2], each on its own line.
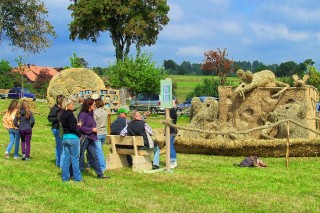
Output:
[202, 48, 236, 85]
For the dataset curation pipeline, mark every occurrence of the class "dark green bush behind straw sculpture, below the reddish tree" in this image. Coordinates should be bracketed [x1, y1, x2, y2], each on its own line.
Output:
[186, 78, 230, 99]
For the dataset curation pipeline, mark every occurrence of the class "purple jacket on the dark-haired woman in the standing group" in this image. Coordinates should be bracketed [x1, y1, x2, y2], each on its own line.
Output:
[78, 111, 98, 141]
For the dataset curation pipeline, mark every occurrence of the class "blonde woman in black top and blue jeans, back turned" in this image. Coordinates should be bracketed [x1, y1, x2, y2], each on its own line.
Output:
[59, 98, 82, 181]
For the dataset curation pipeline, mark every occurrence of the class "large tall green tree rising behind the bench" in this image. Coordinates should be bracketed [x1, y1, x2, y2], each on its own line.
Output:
[68, 0, 170, 61]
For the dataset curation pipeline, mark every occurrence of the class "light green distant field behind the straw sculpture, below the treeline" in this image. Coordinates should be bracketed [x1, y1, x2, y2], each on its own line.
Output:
[168, 75, 239, 103]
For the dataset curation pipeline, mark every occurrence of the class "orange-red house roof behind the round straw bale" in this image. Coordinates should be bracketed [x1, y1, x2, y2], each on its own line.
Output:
[13, 65, 59, 82]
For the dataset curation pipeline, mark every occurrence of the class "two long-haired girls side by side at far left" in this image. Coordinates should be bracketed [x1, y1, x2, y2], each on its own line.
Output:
[2, 99, 35, 160]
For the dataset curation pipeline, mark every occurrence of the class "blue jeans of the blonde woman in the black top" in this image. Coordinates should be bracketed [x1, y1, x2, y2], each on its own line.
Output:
[61, 138, 82, 181]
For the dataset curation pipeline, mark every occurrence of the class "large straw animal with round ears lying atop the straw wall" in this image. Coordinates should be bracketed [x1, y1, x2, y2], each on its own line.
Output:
[234, 69, 289, 100]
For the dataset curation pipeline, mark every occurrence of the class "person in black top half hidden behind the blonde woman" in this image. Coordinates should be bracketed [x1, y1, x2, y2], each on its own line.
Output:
[48, 95, 65, 167]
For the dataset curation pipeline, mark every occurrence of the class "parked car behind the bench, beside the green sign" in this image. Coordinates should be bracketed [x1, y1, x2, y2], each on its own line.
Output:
[129, 94, 175, 113]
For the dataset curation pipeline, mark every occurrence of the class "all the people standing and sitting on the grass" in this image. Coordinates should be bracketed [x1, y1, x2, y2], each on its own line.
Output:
[3, 95, 177, 181]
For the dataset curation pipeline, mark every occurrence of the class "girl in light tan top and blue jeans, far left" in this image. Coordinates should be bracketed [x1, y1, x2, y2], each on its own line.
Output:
[2, 100, 20, 159]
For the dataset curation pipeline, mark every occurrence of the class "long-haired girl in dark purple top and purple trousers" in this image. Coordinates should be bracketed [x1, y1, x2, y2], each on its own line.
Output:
[13, 100, 35, 160]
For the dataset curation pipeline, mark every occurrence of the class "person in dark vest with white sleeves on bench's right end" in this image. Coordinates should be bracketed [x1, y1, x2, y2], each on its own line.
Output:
[120, 110, 160, 169]
